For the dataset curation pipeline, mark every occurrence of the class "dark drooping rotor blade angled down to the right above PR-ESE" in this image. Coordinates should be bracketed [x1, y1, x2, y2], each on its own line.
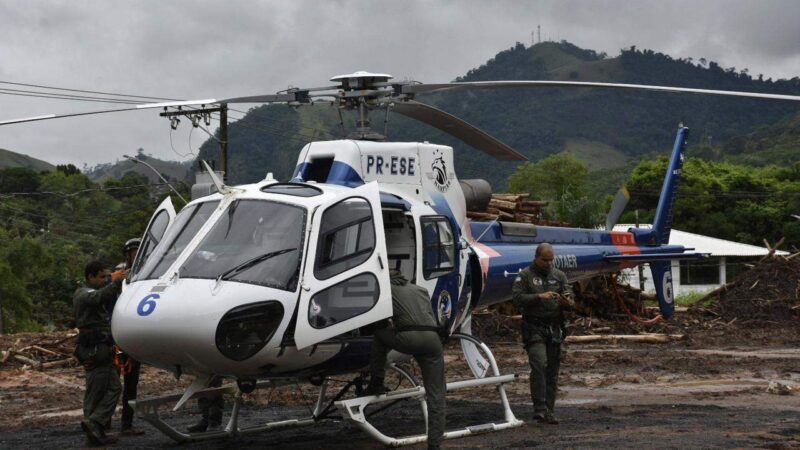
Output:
[392, 100, 528, 161]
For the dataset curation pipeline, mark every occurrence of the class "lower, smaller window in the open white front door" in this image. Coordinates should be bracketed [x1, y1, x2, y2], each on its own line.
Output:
[308, 272, 380, 329]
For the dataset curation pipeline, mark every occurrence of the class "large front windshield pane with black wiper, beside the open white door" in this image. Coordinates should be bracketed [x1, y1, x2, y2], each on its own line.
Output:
[178, 200, 305, 291]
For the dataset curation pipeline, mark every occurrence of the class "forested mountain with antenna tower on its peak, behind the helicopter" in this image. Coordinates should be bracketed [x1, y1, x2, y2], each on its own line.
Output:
[195, 41, 800, 190]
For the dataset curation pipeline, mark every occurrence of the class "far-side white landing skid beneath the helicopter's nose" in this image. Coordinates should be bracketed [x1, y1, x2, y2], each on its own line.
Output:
[129, 379, 328, 442]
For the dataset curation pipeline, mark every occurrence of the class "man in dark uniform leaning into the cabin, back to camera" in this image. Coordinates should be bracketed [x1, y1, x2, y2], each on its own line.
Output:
[367, 270, 446, 449]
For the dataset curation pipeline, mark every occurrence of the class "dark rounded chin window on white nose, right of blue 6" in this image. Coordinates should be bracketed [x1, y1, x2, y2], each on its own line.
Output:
[214, 300, 284, 361]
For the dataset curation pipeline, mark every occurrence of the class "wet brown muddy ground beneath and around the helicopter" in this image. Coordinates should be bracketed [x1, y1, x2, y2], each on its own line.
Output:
[0, 313, 800, 449]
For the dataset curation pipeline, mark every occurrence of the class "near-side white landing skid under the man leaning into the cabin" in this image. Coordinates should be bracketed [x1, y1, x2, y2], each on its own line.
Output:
[336, 333, 524, 447]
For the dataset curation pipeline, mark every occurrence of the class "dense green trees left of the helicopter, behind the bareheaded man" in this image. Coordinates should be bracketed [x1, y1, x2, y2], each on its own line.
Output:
[0, 164, 178, 332]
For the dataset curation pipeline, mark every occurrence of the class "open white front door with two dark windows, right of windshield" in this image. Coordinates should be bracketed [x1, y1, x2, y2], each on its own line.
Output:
[294, 182, 392, 349]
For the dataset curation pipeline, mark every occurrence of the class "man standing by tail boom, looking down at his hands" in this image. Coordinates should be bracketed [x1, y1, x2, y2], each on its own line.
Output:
[512, 243, 575, 424]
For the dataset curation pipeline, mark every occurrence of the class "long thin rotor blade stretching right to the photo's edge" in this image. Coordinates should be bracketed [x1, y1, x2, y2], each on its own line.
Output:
[401, 80, 800, 101]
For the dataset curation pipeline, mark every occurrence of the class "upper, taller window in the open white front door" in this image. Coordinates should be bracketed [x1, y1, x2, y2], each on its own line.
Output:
[314, 197, 375, 280]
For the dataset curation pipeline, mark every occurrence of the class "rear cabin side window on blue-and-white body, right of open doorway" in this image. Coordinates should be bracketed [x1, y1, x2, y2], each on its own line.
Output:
[420, 217, 455, 280]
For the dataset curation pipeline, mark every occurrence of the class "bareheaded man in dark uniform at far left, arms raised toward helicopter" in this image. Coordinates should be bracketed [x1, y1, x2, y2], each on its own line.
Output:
[72, 261, 127, 445]
